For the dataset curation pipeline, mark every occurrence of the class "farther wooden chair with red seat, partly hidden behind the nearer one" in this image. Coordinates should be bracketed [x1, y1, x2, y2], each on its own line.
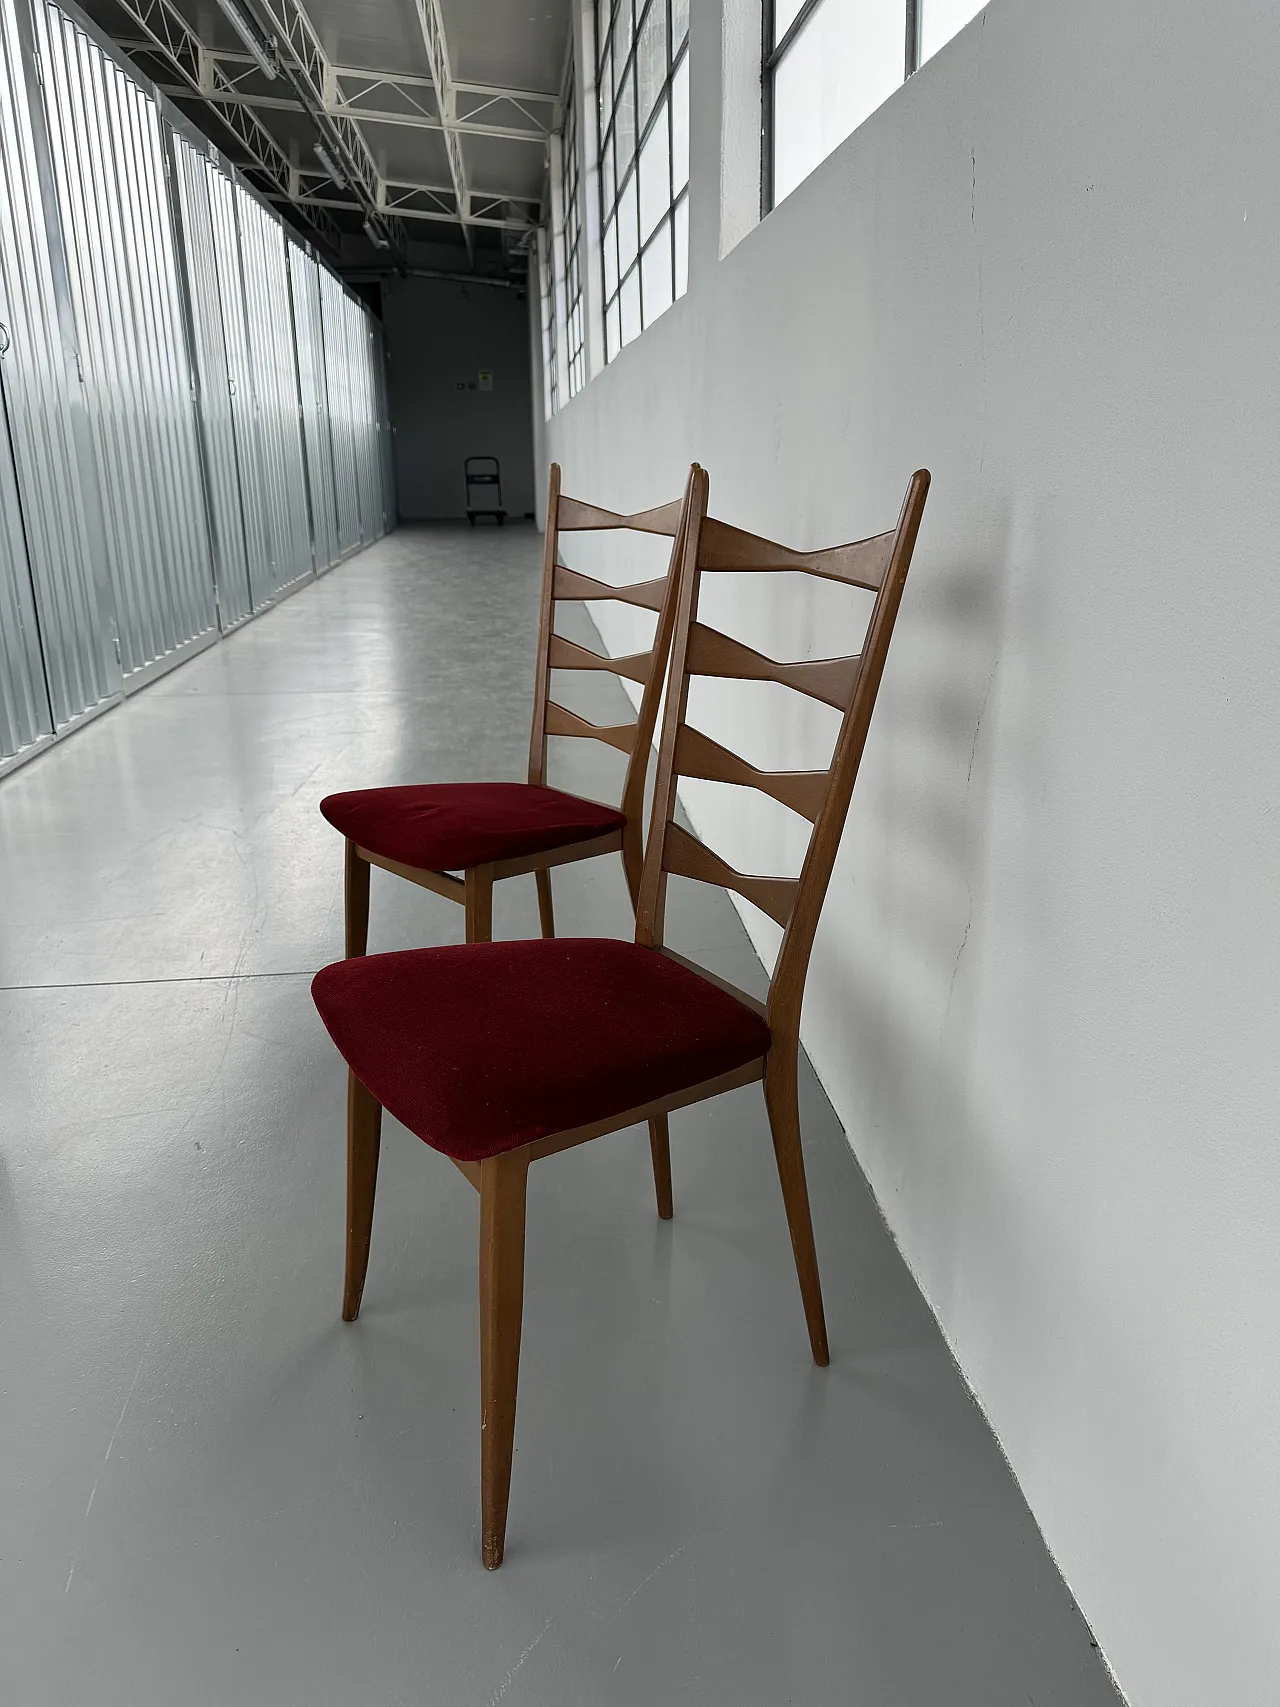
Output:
[321, 463, 691, 956]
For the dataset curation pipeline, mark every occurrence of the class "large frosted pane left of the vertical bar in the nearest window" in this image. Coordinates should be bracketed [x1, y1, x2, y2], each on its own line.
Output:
[773, 0, 905, 201]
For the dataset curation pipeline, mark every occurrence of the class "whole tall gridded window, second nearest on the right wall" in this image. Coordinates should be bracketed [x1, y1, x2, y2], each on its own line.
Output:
[596, 0, 689, 362]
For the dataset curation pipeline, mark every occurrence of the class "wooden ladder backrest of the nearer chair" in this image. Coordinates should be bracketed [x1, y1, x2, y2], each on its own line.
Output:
[635, 466, 928, 1041]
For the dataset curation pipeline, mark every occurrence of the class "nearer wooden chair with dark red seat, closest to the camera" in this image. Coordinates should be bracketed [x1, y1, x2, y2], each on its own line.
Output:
[312, 469, 928, 1570]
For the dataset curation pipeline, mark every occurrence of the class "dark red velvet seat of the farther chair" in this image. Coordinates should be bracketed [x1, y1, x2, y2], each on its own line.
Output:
[321, 782, 626, 871]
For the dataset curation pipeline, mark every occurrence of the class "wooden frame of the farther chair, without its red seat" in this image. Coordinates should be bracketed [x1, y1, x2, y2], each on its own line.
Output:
[345, 463, 693, 959]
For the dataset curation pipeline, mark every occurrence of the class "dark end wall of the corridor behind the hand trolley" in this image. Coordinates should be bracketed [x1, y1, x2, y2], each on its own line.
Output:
[382, 278, 534, 521]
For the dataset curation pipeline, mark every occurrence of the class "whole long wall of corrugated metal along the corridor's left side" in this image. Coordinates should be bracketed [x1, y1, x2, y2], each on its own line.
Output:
[0, 0, 394, 772]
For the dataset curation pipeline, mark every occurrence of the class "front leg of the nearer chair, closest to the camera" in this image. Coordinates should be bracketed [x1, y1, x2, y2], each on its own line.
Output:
[480, 1151, 529, 1570]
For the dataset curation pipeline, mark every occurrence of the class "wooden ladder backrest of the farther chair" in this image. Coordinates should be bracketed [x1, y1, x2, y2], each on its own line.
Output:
[529, 463, 693, 905]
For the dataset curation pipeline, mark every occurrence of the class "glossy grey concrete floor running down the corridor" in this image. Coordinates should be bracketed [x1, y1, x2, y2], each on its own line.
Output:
[0, 527, 1114, 1707]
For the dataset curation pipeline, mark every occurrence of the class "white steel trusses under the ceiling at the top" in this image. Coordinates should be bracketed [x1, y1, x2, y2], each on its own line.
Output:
[105, 0, 561, 259]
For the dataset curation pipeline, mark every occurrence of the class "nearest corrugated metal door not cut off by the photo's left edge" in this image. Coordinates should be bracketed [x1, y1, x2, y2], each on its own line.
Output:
[38, 5, 215, 683]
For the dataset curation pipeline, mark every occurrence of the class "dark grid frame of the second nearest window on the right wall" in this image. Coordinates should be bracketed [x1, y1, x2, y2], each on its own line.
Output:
[592, 0, 691, 364]
